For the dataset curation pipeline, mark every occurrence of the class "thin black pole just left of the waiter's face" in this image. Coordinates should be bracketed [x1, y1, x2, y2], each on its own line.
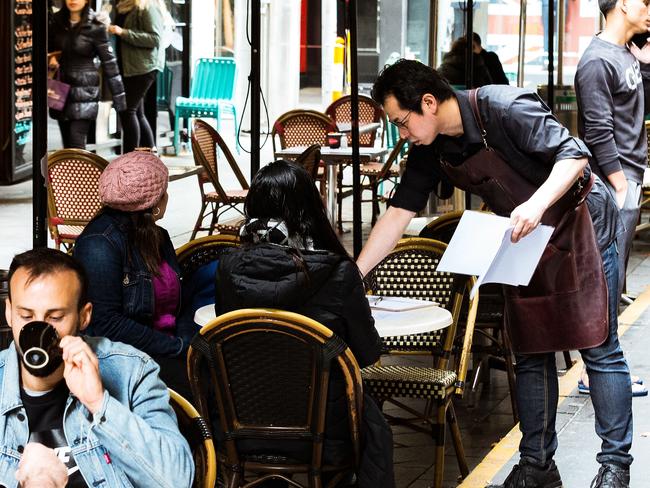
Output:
[347, 0, 362, 259]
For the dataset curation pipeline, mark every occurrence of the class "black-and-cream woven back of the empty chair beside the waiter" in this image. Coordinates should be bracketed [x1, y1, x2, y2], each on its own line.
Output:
[365, 238, 464, 352]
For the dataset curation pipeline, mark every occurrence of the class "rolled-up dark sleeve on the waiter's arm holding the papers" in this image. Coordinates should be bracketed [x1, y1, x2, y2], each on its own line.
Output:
[501, 92, 591, 166]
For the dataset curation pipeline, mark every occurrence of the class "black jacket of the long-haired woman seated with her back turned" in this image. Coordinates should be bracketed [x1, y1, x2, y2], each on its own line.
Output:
[216, 244, 381, 368]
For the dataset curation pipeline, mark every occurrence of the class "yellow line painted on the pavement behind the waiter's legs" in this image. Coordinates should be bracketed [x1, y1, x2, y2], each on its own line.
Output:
[458, 286, 650, 488]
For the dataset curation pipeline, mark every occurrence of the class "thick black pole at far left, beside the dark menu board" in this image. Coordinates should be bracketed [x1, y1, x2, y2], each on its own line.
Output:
[32, 0, 48, 247]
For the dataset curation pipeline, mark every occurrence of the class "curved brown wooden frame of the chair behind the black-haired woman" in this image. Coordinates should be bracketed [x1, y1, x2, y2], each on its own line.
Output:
[188, 309, 363, 488]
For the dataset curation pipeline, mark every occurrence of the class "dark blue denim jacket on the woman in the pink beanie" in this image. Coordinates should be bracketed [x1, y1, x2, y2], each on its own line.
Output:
[73, 208, 185, 358]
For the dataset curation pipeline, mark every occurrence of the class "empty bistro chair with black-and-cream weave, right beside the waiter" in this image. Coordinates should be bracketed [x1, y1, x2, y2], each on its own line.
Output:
[361, 238, 478, 488]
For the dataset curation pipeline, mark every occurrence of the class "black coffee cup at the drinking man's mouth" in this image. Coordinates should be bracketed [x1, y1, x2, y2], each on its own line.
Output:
[18, 321, 63, 377]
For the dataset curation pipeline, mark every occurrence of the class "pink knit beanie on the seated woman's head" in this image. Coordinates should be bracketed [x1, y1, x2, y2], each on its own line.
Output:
[99, 151, 169, 212]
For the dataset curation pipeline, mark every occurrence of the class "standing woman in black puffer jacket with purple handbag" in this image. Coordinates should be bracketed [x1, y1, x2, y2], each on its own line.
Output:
[48, 0, 126, 149]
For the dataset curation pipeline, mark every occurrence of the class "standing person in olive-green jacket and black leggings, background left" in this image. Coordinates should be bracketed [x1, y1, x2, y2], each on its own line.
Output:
[108, 0, 171, 153]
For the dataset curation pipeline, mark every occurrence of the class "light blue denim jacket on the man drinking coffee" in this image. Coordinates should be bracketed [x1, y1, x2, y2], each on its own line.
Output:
[0, 337, 194, 488]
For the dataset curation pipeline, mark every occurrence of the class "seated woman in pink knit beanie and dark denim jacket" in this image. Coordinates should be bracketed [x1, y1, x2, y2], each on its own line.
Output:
[74, 151, 192, 398]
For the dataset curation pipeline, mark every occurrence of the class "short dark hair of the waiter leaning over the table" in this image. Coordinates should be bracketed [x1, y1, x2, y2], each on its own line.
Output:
[372, 59, 454, 114]
